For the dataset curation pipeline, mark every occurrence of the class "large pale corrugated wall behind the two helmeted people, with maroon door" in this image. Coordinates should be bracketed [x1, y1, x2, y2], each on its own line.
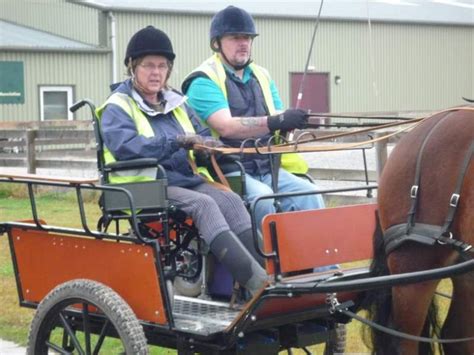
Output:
[116, 13, 474, 112]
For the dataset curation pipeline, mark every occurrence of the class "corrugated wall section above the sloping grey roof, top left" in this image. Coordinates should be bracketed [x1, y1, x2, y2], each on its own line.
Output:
[0, 0, 99, 45]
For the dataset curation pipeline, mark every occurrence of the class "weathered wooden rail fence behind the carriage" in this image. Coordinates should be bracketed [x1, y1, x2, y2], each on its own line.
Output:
[0, 121, 406, 181]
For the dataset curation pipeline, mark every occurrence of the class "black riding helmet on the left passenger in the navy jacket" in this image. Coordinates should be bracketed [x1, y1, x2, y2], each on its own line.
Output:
[124, 26, 176, 66]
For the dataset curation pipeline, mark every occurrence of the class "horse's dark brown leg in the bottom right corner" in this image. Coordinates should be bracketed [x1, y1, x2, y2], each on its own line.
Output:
[441, 272, 474, 355]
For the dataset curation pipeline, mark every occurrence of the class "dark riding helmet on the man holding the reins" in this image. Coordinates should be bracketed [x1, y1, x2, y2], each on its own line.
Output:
[209, 6, 258, 51]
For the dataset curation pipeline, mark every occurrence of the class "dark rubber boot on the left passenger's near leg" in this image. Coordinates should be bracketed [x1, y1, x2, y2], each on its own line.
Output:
[210, 231, 268, 296]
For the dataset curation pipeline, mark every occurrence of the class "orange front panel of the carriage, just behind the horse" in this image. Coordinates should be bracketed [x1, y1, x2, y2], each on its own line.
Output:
[262, 204, 377, 274]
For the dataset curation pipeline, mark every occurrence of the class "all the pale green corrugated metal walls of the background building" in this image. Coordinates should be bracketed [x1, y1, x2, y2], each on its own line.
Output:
[0, 0, 474, 124]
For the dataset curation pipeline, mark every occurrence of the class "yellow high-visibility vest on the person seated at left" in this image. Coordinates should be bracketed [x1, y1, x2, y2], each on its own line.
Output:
[96, 93, 210, 184]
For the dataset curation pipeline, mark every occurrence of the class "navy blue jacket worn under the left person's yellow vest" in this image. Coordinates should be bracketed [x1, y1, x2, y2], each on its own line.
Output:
[101, 79, 211, 187]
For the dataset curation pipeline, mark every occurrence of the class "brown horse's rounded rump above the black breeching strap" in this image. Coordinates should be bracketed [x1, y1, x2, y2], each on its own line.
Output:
[378, 108, 474, 241]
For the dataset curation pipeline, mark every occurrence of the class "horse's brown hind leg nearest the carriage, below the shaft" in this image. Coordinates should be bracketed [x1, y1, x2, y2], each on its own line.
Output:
[392, 281, 439, 354]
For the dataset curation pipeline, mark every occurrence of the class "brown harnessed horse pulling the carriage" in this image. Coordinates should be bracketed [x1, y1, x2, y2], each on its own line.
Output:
[368, 107, 474, 355]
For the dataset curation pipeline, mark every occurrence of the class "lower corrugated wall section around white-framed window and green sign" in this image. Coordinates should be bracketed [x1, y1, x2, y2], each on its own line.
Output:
[0, 52, 110, 121]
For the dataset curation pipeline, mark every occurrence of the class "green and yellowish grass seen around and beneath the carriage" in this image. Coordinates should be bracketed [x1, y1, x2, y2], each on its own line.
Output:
[0, 187, 451, 354]
